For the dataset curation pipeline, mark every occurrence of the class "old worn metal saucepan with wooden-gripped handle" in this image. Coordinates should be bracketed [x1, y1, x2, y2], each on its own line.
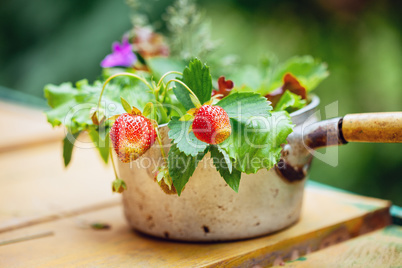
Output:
[116, 97, 402, 241]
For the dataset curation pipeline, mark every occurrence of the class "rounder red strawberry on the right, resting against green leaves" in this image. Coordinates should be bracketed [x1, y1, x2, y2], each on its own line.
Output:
[192, 105, 232, 144]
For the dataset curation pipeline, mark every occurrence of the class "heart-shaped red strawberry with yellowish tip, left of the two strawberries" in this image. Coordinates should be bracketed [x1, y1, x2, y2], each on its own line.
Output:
[110, 113, 156, 163]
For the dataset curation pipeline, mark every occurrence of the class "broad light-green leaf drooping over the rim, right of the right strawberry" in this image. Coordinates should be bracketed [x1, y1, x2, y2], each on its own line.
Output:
[220, 111, 293, 174]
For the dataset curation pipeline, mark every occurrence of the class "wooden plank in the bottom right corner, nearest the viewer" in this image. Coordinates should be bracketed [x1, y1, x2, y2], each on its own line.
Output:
[284, 225, 402, 268]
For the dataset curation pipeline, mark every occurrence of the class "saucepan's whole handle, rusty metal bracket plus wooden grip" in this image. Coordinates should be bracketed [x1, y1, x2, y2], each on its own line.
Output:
[275, 112, 402, 182]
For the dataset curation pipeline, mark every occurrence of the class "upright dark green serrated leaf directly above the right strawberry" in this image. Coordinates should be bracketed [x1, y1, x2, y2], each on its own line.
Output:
[173, 59, 212, 110]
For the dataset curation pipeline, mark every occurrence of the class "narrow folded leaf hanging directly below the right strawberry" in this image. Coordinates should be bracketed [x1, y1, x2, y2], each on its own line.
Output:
[209, 146, 241, 192]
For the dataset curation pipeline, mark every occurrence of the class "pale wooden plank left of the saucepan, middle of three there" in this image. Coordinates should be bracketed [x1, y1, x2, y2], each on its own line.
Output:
[0, 141, 121, 232]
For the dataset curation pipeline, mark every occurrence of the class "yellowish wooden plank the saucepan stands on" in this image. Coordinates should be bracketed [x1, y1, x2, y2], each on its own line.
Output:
[0, 187, 390, 267]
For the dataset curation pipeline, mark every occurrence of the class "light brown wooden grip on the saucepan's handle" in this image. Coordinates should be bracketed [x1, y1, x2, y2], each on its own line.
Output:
[342, 112, 402, 143]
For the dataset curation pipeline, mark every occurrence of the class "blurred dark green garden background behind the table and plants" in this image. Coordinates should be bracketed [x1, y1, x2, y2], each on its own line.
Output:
[0, 0, 402, 205]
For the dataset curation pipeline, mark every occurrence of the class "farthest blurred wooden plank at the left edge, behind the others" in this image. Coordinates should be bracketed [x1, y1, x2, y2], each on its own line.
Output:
[0, 101, 64, 153]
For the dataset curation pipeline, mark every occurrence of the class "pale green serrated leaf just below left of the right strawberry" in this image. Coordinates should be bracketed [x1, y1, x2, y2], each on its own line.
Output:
[168, 117, 208, 156]
